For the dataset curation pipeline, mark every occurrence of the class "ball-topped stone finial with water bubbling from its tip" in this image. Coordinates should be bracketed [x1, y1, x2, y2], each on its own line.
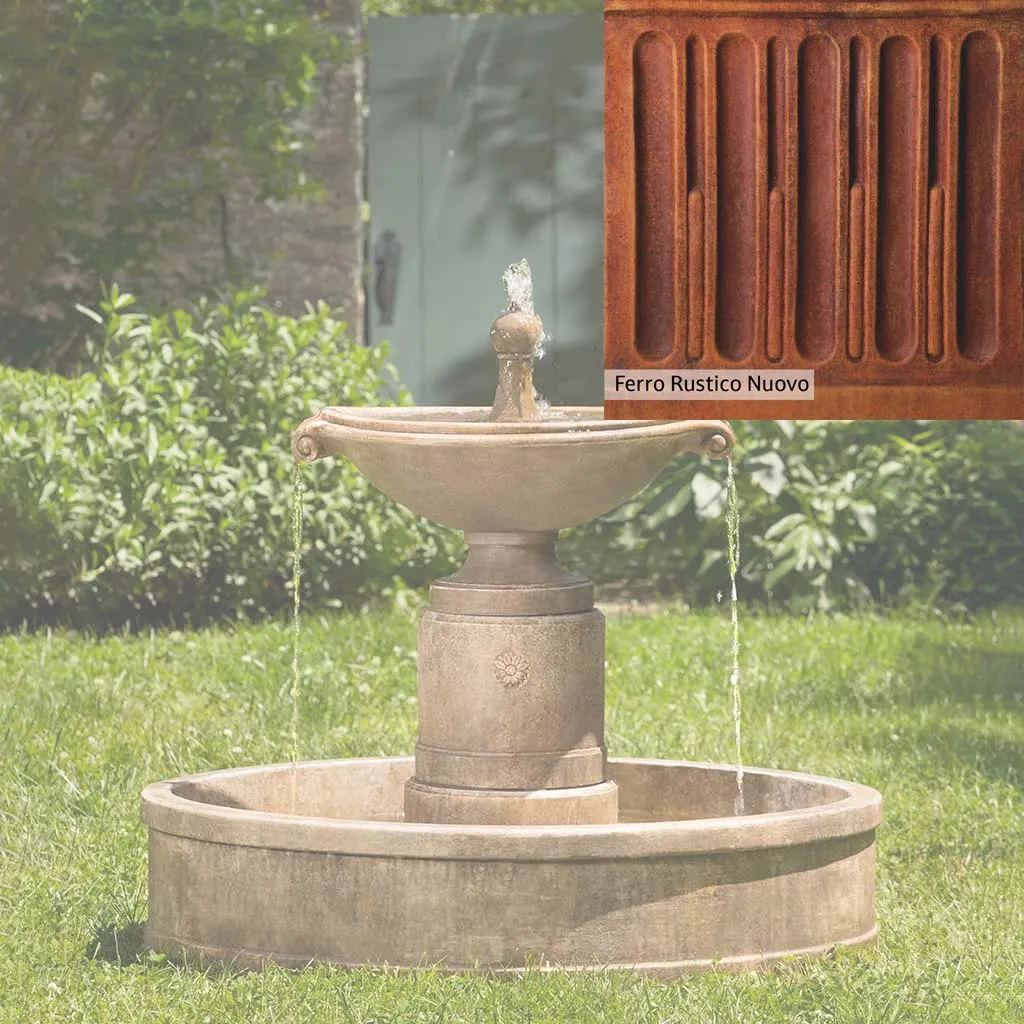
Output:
[489, 259, 544, 422]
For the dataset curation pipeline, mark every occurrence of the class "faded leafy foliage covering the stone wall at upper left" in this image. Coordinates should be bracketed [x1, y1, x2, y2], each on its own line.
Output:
[0, 0, 335, 369]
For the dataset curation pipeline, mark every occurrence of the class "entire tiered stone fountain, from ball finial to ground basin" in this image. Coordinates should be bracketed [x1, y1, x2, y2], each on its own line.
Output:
[142, 278, 881, 976]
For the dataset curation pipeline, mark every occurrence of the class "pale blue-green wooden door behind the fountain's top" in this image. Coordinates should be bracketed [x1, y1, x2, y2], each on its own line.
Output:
[367, 12, 604, 404]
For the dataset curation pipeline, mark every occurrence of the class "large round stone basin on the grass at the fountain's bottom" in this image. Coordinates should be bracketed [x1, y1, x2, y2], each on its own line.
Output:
[142, 758, 882, 977]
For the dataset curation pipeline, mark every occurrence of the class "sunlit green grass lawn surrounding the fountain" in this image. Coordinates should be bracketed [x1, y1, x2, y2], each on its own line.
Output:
[0, 609, 1024, 1024]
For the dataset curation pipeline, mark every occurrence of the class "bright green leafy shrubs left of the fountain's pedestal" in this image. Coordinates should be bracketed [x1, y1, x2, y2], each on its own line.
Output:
[0, 289, 461, 627]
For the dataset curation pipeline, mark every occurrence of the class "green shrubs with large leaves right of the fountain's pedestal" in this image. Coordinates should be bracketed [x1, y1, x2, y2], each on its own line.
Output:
[562, 421, 1024, 608]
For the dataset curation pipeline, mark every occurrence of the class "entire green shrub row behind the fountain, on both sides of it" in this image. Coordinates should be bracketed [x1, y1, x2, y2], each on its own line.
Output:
[0, 290, 1024, 628]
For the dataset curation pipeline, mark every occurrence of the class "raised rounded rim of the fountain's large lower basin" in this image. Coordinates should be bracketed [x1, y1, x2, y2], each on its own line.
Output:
[141, 757, 882, 861]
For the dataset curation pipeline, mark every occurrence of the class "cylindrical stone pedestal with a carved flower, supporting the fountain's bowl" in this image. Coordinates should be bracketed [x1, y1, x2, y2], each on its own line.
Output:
[406, 531, 618, 825]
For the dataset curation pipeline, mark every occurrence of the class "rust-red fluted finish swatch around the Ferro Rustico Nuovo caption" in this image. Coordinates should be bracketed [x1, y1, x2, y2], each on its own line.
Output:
[604, 0, 1024, 419]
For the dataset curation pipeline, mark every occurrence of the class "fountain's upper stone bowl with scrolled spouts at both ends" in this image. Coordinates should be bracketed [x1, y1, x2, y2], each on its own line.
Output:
[292, 407, 733, 534]
